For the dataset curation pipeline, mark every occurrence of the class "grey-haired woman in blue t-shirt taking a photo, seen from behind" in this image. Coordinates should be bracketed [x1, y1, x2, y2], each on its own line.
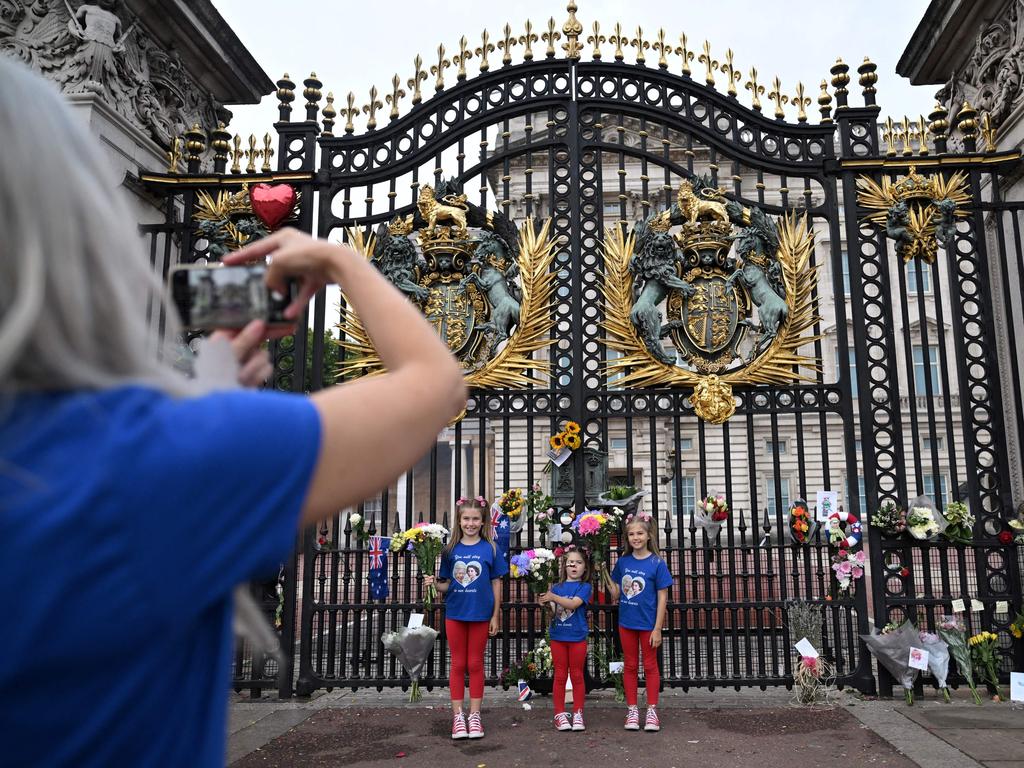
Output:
[0, 59, 466, 766]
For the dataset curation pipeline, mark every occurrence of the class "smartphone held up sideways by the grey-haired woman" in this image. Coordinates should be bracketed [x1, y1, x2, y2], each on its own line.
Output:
[170, 264, 299, 331]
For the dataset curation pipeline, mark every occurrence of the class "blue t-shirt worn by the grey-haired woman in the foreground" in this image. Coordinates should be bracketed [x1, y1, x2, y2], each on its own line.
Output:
[0, 387, 321, 768]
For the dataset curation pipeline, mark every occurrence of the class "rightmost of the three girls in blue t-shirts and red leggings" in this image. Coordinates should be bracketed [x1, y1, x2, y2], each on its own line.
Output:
[603, 512, 672, 731]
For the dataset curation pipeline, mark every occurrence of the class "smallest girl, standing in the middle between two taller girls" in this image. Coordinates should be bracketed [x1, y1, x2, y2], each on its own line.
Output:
[537, 549, 591, 731]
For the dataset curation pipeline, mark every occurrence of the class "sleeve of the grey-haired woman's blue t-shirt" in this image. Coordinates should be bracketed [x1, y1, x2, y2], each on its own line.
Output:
[126, 390, 321, 616]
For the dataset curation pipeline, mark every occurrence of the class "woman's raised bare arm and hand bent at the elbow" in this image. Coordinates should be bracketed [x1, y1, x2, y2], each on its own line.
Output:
[223, 229, 466, 524]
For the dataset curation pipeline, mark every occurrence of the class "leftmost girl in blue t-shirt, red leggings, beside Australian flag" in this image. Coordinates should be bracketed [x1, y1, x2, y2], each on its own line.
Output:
[423, 496, 509, 738]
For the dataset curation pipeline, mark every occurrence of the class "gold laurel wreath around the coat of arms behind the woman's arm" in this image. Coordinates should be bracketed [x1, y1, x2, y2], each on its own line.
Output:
[335, 219, 558, 389]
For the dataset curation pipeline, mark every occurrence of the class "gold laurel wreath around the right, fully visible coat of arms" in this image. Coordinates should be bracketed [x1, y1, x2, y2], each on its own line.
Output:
[602, 213, 822, 387]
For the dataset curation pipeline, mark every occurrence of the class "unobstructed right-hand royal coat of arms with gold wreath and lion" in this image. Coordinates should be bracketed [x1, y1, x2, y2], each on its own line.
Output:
[604, 178, 818, 424]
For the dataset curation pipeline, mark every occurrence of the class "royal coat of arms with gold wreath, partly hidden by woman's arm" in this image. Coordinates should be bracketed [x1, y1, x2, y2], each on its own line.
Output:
[338, 181, 556, 388]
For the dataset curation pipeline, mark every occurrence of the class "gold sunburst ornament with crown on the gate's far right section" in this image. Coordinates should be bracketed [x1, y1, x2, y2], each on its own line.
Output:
[857, 166, 971, 264]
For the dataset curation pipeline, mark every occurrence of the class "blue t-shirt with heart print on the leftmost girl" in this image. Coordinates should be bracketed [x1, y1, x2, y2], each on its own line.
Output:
[437, 539, 509, 622]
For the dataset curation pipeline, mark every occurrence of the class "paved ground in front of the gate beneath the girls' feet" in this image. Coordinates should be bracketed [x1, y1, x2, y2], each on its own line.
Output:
[228, 690, 1024, 768]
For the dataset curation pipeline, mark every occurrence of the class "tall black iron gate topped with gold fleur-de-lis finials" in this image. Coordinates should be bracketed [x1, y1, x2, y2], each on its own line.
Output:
[140, 4, 1024, 695]
